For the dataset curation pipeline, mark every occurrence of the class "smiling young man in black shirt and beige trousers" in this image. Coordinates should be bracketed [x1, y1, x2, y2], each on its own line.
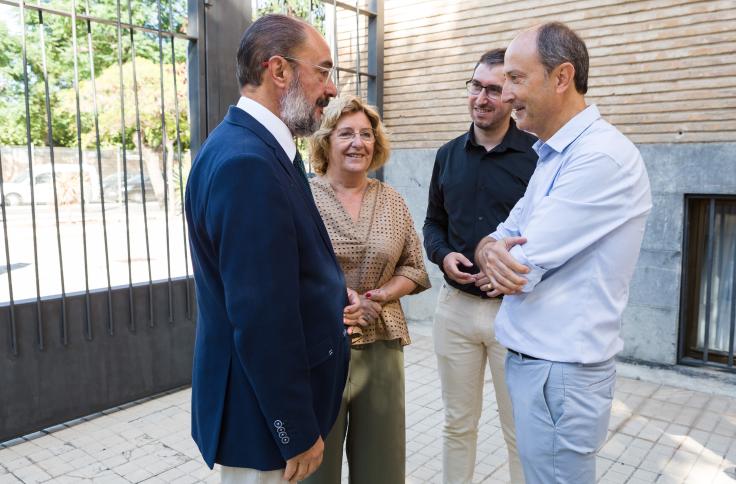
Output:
[424, 49, 537, 483]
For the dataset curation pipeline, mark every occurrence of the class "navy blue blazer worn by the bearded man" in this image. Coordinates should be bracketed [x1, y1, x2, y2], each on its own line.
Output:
[186, 106, 350, 470]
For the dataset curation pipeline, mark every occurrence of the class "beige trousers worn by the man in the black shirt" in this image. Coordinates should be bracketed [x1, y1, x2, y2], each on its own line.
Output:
[434, 283, 524, 484]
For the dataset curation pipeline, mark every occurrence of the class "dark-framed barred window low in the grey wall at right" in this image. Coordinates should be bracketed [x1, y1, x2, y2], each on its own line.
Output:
[679, 195, 736, 370]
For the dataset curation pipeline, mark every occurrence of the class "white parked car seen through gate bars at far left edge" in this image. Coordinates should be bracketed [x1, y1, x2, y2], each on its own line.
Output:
[3, 163, 100, 206]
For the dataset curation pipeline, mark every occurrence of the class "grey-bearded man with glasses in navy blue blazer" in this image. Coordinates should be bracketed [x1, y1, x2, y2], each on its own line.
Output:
[186, 15, 357, 483]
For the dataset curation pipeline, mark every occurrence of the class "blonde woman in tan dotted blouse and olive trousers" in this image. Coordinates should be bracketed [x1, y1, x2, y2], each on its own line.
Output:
[305, 96, 430, 484]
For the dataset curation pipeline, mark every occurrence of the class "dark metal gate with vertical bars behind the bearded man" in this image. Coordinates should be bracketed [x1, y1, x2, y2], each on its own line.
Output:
[0, 0, 383, 442]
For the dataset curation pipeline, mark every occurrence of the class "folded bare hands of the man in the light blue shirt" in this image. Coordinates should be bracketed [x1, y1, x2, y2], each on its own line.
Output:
[475, 237, 529, 297]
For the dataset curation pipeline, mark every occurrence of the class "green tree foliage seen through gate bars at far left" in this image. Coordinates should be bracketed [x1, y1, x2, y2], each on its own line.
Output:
[0, 0, 189, 148]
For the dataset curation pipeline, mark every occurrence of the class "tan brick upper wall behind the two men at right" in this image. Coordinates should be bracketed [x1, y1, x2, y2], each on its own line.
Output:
[384, 0, 736, 148]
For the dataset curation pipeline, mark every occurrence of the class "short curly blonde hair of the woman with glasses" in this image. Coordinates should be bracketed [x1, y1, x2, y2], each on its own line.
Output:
[309, 95, 391, 175]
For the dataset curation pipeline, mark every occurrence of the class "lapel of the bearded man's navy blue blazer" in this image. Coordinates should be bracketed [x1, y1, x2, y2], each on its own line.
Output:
[225, 106, 338, 264]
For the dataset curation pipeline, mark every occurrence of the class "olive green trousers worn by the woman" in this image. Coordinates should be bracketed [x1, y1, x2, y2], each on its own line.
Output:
[304, 340, 406, 484]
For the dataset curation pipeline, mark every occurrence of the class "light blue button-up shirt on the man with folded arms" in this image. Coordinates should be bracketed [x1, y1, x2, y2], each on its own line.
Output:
[491, 106, 652, 363]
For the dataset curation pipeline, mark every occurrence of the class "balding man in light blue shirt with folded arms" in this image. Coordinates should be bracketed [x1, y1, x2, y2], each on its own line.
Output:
[476, 22, 652, 484]
